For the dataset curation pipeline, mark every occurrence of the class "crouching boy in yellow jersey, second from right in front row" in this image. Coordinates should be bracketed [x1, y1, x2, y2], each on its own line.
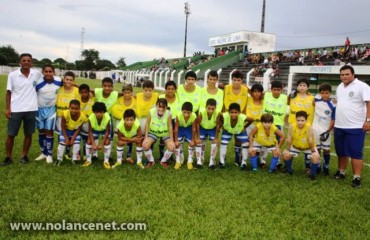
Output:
[249, 113, 285, 172]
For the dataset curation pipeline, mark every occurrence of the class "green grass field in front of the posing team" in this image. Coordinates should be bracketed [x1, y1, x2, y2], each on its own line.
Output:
[0, 76, 370, 239]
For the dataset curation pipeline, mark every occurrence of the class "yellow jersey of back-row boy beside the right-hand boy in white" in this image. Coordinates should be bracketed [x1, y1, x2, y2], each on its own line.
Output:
[288, 95, 315, 124]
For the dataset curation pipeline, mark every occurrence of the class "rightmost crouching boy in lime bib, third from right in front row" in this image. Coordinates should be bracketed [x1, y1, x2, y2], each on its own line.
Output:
[218, 103, 249, 169]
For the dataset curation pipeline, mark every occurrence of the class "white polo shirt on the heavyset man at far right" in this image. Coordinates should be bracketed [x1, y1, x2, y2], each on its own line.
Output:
[334, 78, 370, 129]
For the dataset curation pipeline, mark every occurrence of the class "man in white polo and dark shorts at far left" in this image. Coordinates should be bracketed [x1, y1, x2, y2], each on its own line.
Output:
[0, 53, 42, 166]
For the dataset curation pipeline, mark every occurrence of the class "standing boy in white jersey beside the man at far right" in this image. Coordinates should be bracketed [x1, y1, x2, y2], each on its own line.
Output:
[312, 83, 335, 176]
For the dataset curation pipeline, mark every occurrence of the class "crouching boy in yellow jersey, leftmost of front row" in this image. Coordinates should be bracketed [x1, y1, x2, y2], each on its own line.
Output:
[56, 99, 87, 165]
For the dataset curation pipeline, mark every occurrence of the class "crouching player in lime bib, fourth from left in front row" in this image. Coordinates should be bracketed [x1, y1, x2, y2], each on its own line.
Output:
[143, 98, 175, 168]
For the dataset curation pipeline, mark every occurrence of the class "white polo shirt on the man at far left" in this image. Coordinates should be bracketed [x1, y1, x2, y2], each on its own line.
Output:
[6, 69, 42, 112]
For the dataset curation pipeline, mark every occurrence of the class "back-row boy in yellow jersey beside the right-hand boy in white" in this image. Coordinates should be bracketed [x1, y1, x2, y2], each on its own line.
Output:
[288, 78, 315, 124]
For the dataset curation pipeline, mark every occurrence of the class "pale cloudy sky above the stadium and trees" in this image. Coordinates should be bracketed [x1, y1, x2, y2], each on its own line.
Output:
[0, 0, 370, 64]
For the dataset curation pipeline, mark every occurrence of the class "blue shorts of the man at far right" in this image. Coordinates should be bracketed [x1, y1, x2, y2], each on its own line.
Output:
[334, 128, 365, 159]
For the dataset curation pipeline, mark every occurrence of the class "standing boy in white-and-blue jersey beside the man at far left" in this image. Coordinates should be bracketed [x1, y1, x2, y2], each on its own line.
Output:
[35, 64, 62, 163]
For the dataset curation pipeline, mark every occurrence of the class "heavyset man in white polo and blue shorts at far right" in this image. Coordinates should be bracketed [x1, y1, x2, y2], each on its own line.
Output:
[334, 65, 370, 187]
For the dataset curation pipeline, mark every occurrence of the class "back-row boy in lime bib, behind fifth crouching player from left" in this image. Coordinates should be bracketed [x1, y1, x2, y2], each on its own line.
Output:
[177, 71, 202, 113]
